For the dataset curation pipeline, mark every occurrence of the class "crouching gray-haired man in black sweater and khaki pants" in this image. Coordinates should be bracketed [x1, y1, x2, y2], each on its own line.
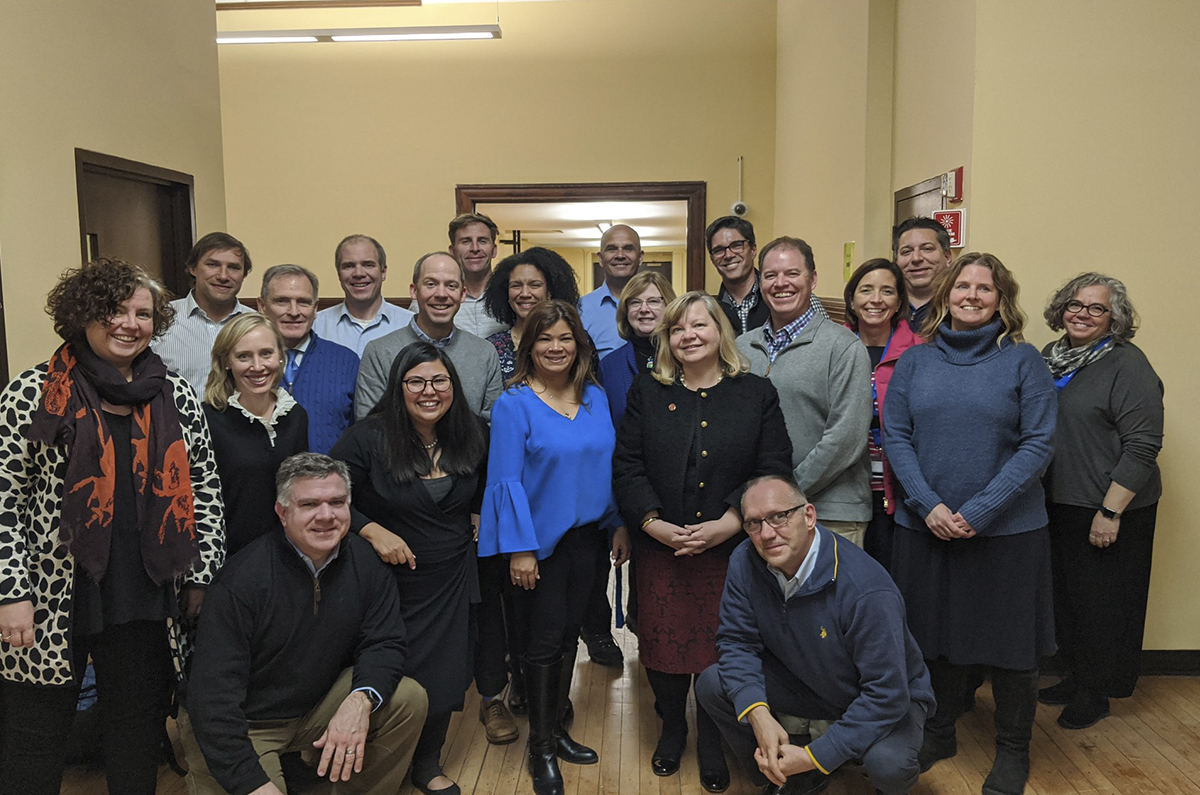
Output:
[180, 453, 427, 795]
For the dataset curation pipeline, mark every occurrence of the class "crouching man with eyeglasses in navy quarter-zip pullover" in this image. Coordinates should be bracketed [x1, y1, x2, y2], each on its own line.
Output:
[696, 476, 934, 795]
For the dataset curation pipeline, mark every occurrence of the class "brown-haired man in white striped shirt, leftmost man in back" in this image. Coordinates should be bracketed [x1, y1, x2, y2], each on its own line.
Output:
[152, 232, 254, 399]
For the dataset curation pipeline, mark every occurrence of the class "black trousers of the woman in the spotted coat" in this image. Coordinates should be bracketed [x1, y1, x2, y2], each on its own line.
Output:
[0, 621, 172, 795]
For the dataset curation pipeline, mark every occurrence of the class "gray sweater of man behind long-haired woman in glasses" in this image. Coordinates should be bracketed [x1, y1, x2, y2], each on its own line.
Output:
[354, 321, 502, 419]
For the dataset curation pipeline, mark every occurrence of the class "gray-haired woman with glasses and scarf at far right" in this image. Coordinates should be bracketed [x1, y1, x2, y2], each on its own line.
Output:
[1038, 273, 1163, 729]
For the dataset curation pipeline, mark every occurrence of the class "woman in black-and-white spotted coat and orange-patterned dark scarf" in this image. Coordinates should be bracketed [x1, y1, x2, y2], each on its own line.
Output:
[0, 261, 224, 795]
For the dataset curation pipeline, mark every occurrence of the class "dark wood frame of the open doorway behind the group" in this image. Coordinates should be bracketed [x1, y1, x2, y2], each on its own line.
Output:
[454, 183, 708, 289]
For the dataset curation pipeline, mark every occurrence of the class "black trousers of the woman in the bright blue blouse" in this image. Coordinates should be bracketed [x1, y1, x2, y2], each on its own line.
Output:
[517, 524, 605, 665]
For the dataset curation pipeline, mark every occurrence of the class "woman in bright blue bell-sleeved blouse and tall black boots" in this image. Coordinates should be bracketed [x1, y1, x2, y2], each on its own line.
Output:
[479, 300, 628, 795]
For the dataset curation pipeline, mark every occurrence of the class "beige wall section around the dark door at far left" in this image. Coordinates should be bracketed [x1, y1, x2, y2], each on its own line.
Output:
[0, 0, 224, 373]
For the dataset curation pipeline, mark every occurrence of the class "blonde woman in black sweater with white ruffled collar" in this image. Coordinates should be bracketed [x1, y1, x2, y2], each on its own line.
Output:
[204, 312, 308, 555]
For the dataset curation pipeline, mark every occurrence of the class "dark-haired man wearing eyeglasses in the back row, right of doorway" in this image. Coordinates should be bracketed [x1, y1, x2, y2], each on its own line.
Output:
[704, 215, 828, 336]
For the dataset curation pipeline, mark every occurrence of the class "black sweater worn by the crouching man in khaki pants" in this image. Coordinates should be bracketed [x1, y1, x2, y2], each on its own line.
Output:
[187, 531, 406, 793]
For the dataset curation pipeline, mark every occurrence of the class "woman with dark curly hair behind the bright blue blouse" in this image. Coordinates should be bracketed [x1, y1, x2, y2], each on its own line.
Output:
[484, 246, 580, 382]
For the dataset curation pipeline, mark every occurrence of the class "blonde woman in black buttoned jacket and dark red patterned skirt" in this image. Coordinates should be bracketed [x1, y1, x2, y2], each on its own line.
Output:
[613, 292, 792, 793]
